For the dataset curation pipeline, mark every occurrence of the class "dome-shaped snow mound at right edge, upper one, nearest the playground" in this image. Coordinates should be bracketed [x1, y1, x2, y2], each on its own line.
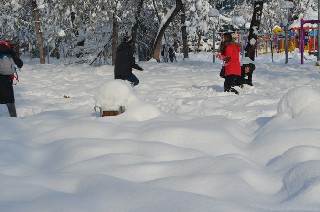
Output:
[278, 87, 320, 118]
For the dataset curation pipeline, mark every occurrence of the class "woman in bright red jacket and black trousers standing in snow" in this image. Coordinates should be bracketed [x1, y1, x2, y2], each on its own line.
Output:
[217, 33, 241, 94]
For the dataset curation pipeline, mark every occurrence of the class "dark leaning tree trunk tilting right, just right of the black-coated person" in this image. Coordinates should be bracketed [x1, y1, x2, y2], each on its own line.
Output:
[153, 0, 182, 62]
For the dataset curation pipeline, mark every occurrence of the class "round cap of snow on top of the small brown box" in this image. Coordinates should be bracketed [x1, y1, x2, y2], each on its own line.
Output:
[95, 80, 133, 110]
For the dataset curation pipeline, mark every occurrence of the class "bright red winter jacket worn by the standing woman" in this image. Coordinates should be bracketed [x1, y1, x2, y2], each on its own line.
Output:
[220, 43, 241, 76]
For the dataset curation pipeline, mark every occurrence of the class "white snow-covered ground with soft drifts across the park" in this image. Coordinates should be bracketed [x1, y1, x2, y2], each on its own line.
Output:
[0, 53, 320, 212]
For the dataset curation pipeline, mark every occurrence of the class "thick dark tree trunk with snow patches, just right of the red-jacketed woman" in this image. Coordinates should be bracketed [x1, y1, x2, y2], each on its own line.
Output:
[245, 0, 263, 61]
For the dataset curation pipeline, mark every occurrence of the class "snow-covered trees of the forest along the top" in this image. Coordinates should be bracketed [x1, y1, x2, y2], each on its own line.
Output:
[0, 0, 318, 66]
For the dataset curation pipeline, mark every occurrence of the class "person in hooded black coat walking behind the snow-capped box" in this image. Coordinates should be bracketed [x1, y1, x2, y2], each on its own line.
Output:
[114, 36, 143, 86]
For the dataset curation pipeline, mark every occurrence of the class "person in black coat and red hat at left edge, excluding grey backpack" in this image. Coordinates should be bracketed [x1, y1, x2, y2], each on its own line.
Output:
[0, 41, 23, 117]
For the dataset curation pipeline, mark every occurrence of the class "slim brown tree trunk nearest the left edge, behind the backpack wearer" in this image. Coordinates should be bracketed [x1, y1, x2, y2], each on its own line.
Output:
[32, 0, 46, 64]
